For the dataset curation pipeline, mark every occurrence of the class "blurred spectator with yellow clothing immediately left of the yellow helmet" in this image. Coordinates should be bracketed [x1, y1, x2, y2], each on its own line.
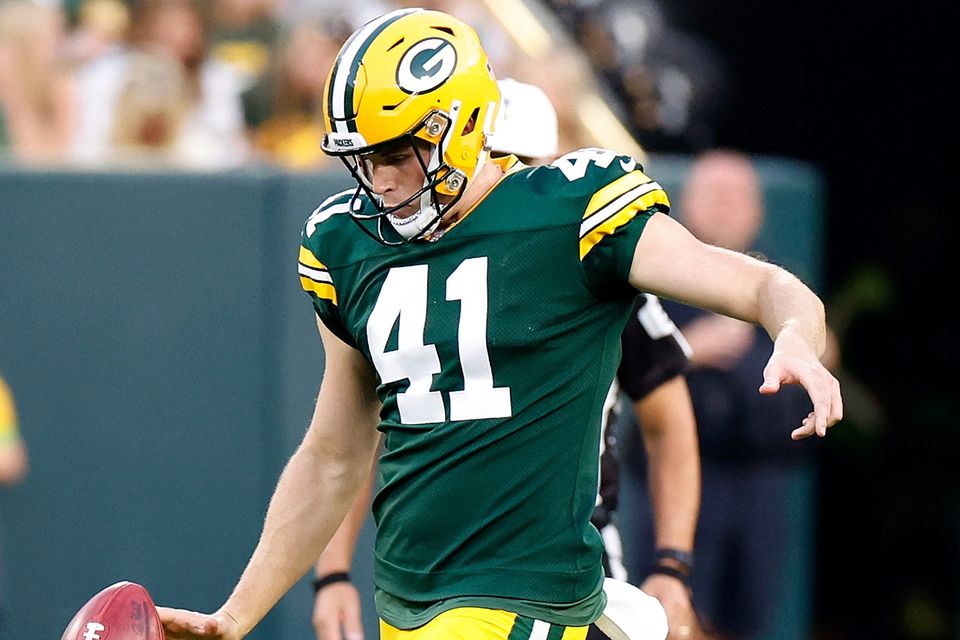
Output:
[243, 21, 349, 171]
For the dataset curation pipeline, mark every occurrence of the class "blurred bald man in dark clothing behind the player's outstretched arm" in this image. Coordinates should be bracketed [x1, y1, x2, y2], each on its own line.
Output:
[622, 150, 836, 640]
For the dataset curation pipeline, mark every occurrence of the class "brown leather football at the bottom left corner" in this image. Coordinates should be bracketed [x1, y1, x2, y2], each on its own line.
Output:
[60, 580, 165, 640]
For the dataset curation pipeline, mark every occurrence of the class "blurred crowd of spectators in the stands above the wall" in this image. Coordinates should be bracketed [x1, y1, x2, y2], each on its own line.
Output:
[0, 0, 724, 170]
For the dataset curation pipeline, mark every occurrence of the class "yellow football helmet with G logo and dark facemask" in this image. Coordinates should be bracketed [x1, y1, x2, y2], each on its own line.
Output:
[321, 9, 500, 244]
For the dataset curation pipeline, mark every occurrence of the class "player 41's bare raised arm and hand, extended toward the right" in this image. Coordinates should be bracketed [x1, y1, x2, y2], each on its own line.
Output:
[630, 213, 843, 440]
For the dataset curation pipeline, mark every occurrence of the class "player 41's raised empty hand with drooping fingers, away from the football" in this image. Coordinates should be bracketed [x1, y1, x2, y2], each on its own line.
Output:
[760, 332, 843, 440]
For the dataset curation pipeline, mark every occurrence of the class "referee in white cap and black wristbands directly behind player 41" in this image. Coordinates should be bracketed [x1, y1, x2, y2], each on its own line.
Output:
[312, 78, 700, 640]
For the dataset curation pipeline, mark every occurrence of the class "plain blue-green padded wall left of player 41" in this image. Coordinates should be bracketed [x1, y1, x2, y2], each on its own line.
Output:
[0, 170, 344, 640]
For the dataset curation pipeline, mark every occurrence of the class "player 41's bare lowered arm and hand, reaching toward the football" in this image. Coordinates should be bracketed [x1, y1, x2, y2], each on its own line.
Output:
[158, 323, 380, 640]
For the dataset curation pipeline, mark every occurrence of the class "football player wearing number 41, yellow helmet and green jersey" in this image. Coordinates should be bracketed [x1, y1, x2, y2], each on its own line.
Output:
[159, 9, 842, 640]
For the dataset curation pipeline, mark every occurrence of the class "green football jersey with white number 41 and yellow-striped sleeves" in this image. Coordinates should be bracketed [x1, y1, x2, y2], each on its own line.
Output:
[299, 149, 669, 628]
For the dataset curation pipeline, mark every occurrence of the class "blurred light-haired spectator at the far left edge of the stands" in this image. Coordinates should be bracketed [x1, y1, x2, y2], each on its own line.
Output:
[0, 0, 74, 163]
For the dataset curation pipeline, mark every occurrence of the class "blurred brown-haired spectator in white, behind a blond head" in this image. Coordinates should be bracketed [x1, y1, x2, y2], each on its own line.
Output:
[75, 0, 250, 170]
